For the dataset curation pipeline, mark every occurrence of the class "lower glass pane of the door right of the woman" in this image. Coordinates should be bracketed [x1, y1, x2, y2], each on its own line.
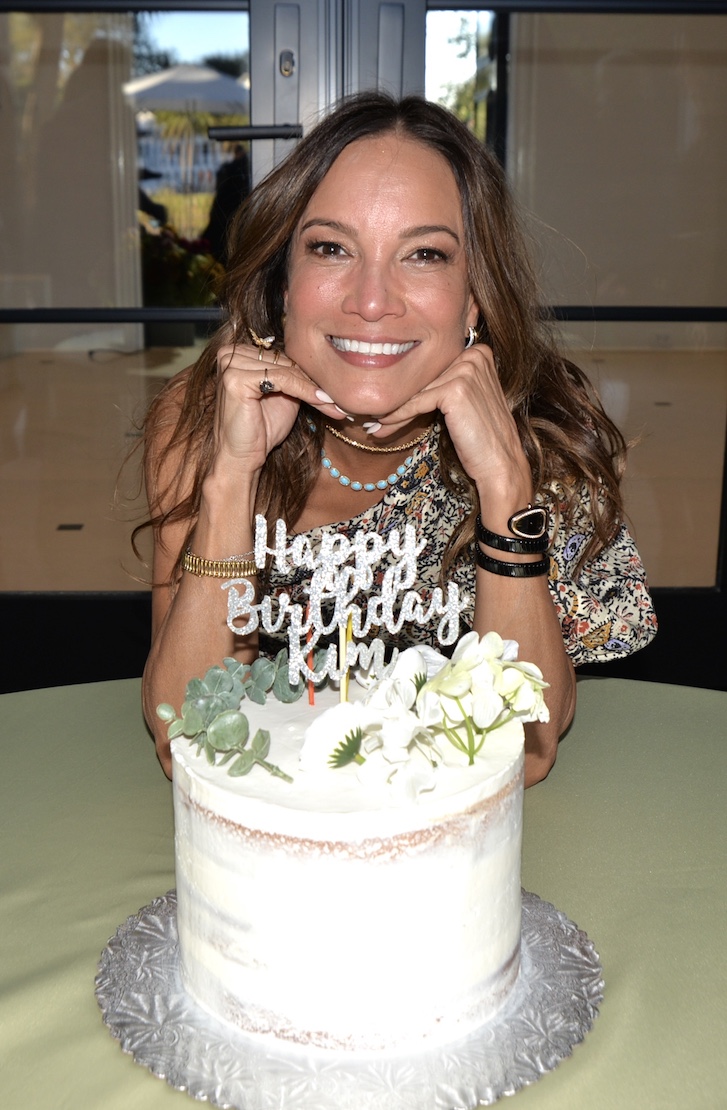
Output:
[568, 324, 727, 587]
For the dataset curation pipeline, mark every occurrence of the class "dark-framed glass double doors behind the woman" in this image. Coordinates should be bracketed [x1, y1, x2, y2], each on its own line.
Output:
[0, 0, 727, 688]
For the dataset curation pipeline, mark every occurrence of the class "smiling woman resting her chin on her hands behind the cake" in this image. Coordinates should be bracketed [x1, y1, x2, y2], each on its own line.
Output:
[138, 93, 655, 785]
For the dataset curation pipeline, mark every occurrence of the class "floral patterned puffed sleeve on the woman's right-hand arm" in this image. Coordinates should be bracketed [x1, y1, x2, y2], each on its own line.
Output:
[548, 487, 657, 667]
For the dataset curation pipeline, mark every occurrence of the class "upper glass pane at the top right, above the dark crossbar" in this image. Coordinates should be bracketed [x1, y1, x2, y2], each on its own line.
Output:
[507, 14, 727, 317]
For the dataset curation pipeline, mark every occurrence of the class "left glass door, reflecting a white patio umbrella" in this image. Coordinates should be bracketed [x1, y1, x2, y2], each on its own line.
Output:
[0, 0, 250, 689]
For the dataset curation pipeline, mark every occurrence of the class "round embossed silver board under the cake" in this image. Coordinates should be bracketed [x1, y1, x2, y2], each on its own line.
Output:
[95, 890, 604, 1110]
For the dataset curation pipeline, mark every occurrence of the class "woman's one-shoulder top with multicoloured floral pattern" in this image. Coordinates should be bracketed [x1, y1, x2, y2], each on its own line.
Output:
[261, 426, 656, 666]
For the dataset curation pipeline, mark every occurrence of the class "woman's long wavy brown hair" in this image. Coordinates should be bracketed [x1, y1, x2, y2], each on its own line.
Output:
[137, 92, 626, 579]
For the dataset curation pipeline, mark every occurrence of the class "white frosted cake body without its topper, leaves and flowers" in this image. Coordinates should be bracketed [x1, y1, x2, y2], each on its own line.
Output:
[167, 637, 537, 1052]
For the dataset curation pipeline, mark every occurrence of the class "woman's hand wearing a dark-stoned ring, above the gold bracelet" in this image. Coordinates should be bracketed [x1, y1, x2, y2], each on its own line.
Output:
[215, 344, 346, 472]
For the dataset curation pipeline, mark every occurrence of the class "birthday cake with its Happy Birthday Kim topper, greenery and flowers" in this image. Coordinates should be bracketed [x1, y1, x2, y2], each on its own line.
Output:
[158, 517, 547, 1052]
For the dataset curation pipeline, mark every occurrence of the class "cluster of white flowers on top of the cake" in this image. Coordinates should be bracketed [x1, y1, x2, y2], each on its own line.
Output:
[301, 632, 548, 797]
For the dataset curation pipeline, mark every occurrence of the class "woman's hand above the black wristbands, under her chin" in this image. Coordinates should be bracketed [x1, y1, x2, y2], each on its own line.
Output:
[370, 344, 532, 507]
